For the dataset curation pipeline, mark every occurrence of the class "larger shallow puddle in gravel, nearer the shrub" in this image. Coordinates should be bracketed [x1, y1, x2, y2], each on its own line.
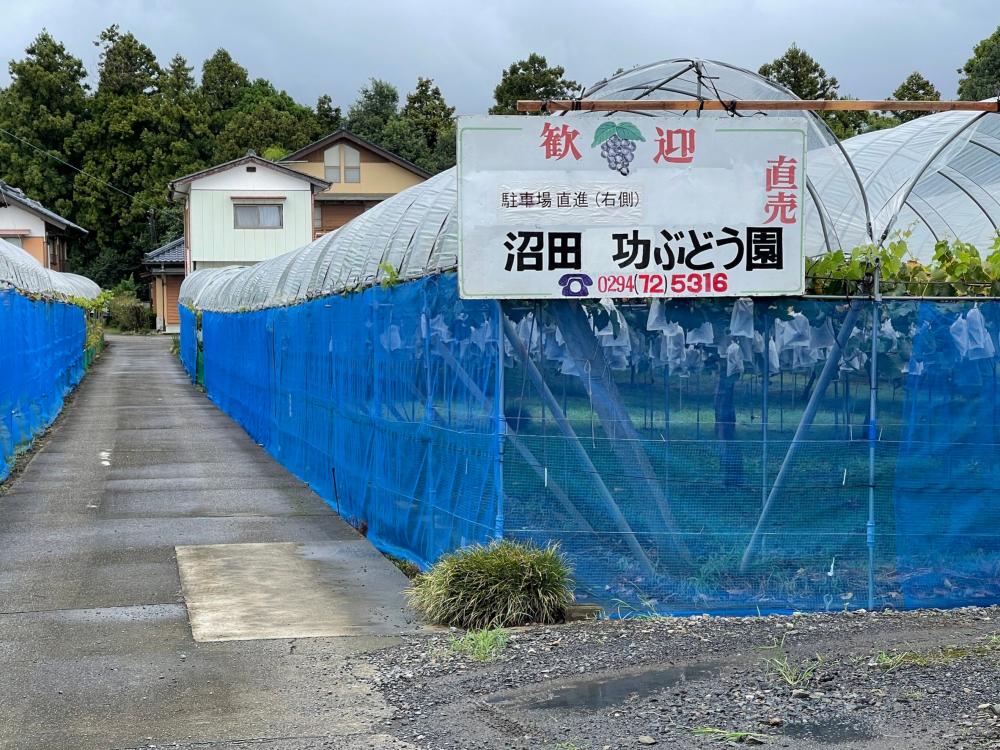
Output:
[491, 664, 718, 709]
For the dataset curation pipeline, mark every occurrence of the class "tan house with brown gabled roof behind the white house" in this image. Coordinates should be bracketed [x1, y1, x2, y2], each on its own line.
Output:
[279, 128, 431, 237]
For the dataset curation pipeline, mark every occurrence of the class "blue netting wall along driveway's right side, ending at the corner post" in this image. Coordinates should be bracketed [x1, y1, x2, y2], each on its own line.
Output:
[197, 276, 500, 565]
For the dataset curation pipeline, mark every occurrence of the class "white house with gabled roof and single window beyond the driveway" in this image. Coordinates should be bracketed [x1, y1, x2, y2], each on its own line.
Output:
[170, 152, 330, 273]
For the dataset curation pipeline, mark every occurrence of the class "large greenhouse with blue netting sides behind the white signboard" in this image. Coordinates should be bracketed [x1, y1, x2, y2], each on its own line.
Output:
[181, 60, 1000, 615]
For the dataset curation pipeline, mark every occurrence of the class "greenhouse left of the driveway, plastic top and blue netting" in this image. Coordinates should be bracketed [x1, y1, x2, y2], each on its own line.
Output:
[0, 240, 101, 480]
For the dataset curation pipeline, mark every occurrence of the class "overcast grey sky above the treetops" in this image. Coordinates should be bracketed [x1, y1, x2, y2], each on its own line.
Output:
[0, 0, 1000, 114]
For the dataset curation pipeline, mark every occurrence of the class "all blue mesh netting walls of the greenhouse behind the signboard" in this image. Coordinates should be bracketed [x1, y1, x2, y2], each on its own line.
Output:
[182, 275, 1000, 614]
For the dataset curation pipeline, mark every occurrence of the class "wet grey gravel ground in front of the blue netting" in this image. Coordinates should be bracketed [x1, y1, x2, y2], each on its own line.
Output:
[358, 607, 1000, 750]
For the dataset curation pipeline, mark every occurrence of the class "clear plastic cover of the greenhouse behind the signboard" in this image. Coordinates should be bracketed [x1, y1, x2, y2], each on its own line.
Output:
[180, 59, 1000, 311]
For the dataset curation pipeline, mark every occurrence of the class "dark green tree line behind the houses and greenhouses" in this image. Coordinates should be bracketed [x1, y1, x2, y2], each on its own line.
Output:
[0, 26, 1000, 287]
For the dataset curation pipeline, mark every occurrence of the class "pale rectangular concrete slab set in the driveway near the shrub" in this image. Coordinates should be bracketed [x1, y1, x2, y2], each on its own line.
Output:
[177, 539, 416, 642]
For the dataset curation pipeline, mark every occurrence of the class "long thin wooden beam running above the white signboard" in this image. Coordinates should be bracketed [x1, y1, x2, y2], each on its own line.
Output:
[517, 99, 1000, 112]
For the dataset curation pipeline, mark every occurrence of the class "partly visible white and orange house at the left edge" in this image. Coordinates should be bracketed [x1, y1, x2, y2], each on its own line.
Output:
[0, 180, 87, 271]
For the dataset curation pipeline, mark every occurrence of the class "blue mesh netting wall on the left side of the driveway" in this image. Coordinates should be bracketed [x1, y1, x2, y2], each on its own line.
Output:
[0, 289, 87, 480]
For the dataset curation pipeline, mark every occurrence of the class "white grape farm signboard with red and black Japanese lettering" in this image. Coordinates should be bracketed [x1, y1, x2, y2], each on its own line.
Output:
[458, 113, 806, 299]
